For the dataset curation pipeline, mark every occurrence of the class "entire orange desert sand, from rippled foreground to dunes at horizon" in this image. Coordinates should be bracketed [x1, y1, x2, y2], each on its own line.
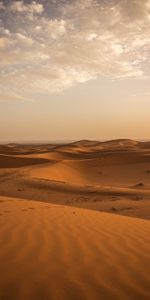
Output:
[0, 140, 150, 300]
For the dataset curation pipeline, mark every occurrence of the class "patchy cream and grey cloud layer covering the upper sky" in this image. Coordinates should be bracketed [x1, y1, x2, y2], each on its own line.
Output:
[0, 0, 150, 101]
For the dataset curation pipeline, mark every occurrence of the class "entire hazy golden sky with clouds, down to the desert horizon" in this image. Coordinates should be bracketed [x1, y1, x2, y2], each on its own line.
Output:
[0, 0, 150, 142]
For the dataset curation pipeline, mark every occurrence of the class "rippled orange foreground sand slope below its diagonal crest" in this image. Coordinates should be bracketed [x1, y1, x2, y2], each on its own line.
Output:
[0, 197, 150, 300]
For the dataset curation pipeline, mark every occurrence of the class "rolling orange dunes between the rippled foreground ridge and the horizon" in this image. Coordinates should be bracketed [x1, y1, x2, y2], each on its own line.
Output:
[0, 139, 150, 219]
